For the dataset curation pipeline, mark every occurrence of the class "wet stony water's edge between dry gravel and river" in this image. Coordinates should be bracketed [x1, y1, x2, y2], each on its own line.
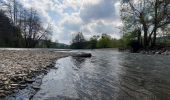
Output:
[4, 59, 64, 100]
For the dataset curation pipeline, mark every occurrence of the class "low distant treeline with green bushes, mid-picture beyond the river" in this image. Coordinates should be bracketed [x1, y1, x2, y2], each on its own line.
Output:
[70, 32, 122, 49]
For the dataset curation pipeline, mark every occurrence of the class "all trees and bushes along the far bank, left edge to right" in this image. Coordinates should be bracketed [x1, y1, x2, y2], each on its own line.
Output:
[0, 0, 170, 52]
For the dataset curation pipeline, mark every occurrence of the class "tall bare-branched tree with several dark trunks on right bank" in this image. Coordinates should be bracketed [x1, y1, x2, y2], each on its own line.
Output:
[121, 0, 170, 49]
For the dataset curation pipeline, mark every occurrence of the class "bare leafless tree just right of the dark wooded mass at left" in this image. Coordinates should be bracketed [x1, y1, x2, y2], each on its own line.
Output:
[26, 9, 52, 47]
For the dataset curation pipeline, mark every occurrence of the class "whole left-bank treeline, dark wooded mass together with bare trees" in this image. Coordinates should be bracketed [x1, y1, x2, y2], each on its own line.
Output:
[0, 0, 52, 48]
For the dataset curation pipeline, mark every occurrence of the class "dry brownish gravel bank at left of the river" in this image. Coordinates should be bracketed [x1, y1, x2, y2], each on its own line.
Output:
[0, 50, 70, 97]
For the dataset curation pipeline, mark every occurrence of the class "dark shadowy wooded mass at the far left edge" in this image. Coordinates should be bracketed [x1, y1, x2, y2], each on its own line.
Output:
[0, 11, 23, 47]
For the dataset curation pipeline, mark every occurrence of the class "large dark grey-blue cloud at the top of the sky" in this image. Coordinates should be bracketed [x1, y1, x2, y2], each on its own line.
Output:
[80, 0, 117, 22]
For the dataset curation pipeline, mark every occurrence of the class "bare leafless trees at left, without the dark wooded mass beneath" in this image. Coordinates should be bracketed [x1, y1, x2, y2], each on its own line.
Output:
[1, 0, 52, 48]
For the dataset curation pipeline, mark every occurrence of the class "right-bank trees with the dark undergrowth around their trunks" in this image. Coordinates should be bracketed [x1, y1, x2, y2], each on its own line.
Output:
[121, 0, 170, 50]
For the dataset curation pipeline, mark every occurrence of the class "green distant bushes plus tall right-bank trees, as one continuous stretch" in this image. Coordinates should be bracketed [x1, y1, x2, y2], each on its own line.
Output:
[68, 0, 170, 54]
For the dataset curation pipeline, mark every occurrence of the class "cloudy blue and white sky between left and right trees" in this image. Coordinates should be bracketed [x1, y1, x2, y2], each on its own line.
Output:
[19, 0, 122, 44]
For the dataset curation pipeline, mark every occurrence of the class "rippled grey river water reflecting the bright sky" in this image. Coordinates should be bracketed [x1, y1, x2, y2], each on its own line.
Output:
[32, 50, 170, 100]
